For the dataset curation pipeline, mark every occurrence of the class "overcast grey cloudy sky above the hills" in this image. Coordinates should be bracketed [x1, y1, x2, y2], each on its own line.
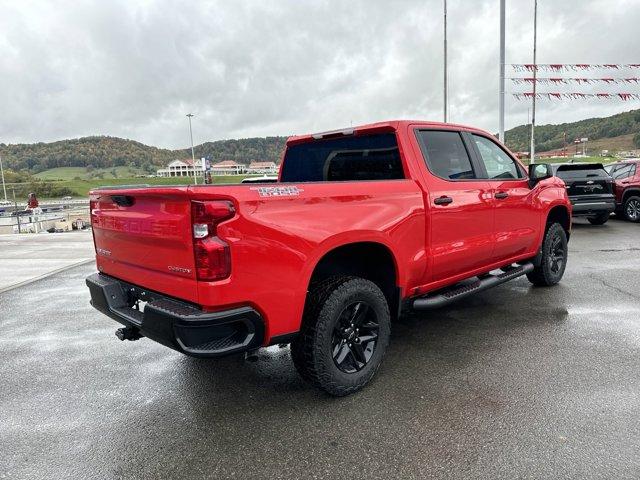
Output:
[0, 0, 640, 148]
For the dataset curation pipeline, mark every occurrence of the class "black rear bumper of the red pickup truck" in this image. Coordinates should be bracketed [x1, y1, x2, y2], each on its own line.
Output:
[86, 273, 264, 357]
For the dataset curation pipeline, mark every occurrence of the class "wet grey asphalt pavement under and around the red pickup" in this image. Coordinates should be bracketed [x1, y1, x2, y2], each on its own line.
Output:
[0, 220, 640, 479]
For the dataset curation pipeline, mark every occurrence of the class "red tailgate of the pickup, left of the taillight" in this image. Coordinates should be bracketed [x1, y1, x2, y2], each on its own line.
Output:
[91, 186, 198, 302]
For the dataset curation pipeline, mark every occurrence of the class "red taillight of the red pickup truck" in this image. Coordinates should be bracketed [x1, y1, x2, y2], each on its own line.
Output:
[191, 200, 235, 281]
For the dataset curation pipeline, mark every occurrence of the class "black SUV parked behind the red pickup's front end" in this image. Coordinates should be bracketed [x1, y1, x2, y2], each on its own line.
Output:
[551, 163, 616, 225]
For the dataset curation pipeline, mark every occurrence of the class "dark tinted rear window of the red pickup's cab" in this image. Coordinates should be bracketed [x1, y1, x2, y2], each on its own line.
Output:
[280, 133, 404, 182]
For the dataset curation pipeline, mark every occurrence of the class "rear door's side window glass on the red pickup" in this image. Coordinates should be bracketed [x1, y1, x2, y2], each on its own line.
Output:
[416, 130, 477, 180]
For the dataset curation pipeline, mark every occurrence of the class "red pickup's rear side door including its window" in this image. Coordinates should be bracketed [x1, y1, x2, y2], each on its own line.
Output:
[415, 128, 494, 282]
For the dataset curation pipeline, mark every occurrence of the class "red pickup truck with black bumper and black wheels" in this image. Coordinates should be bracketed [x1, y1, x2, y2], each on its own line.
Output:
[87, 121, 571, 395]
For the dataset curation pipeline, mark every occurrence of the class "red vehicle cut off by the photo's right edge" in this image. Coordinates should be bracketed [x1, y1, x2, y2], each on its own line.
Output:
[605, 158, 640, 222]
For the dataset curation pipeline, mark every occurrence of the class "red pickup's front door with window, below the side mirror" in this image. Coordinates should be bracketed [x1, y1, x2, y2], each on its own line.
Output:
[466, 133, 540, 261]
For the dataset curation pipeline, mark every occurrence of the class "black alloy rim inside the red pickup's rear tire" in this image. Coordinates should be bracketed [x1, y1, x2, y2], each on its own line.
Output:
[331, 301, 380, 373]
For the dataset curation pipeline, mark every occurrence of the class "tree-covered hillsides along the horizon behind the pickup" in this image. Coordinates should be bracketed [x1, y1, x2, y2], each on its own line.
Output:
[0, 110, 640, 181]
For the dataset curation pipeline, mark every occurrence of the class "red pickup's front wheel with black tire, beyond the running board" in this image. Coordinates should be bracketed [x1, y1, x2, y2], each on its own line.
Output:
[527, 223, 568, 287]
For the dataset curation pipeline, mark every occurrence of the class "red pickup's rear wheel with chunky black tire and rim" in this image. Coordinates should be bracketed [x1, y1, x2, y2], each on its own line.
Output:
[291, 277, 391, 396]
